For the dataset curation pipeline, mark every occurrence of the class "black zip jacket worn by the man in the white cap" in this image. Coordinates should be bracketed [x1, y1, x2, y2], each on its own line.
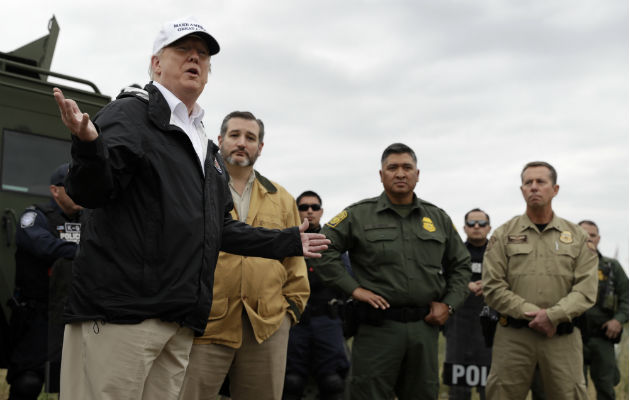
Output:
[65, 84, 302, 335]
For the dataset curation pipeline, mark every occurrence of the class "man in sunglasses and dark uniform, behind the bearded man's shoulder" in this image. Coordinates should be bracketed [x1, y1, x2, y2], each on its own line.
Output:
[282, 190, 350, 400]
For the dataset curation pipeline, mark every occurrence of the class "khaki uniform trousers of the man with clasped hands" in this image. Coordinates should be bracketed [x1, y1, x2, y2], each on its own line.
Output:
[486, 325, 588, 400]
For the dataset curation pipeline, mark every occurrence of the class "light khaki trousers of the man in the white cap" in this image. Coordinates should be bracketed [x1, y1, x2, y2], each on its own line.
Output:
[60, 319, 193, 400]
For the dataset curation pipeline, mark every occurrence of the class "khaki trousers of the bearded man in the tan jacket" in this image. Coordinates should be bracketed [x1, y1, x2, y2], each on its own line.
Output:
[180, 315, 291, 400]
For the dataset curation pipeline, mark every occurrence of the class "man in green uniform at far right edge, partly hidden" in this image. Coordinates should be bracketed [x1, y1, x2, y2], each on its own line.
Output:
[579, 221, 628, 400]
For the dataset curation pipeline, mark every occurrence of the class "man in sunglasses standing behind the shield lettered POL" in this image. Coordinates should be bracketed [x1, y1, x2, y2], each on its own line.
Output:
[443, 208, 491, 400]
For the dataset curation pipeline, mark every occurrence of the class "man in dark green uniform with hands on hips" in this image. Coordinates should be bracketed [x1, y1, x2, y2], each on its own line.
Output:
[313, 143, 471, 400]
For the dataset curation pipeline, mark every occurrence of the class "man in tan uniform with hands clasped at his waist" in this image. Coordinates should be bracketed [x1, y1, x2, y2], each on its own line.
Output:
[482, 161, 597, 400]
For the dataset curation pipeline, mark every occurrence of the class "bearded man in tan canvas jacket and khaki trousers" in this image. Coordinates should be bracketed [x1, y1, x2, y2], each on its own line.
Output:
[180, 111, 309, 400]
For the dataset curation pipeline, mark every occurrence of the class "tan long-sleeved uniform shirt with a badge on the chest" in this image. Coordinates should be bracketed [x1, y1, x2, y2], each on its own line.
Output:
[482, 215, 597, 326]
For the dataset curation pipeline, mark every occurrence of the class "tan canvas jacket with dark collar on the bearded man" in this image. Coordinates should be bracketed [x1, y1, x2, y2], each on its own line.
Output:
[195, 172, 310, 348]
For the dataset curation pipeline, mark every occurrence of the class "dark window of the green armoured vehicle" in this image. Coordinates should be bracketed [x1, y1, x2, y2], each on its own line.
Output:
[1, 129, 70, 197]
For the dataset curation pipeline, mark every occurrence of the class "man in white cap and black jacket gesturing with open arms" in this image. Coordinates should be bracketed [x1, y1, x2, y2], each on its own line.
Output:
[54, 18, 327, 399]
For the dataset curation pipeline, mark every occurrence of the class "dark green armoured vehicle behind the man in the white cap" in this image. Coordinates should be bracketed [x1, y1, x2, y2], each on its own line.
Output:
[0, 16, 110, 361]
